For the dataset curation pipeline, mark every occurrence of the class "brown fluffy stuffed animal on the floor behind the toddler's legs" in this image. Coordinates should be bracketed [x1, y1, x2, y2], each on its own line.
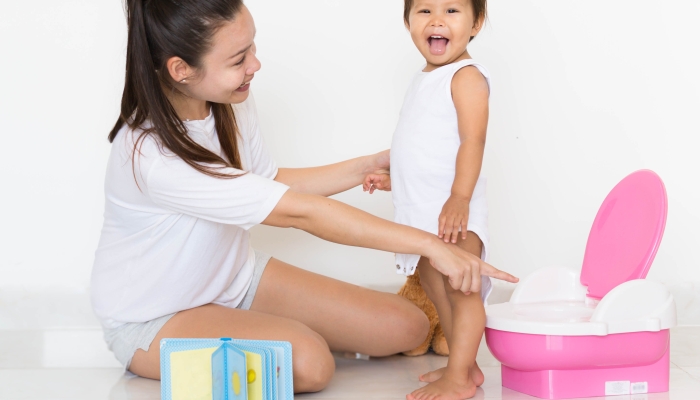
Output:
[399, 271, 450, 356]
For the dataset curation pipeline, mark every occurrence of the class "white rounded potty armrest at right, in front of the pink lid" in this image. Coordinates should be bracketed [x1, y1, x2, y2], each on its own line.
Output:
[591, 279, 676, 334]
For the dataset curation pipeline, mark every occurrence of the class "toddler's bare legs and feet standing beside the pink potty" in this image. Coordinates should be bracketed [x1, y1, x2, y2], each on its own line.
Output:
[407, 232, 486, 400]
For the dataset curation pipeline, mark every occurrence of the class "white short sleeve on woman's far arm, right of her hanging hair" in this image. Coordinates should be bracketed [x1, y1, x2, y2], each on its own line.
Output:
[234, 93, 278, 179]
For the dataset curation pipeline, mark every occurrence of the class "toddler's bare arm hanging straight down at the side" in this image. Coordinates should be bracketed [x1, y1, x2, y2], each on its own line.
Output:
[438, 67, 489, 243]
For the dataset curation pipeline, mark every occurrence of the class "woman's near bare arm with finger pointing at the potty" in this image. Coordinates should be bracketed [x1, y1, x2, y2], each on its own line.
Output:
[263, 190, 518, 293]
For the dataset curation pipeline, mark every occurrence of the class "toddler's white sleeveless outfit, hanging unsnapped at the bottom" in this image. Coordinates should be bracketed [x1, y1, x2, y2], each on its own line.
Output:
[391, 59, 491, 295]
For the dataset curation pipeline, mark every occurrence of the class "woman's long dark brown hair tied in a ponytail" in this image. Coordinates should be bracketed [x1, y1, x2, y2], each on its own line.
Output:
[109, 0, 243, 178]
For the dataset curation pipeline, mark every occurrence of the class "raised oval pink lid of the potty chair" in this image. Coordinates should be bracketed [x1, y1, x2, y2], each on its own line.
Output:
[581, 170, 668, 299]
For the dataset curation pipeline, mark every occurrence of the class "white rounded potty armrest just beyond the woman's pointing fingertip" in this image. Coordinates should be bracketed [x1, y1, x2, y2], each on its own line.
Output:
[510, 267, 586, 304]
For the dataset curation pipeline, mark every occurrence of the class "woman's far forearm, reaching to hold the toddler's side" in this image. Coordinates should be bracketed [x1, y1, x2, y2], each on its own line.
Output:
[275, 150, 389, 196]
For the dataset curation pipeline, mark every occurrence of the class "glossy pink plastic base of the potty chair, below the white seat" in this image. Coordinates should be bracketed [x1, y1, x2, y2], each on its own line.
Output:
[486, 328, 670, 399]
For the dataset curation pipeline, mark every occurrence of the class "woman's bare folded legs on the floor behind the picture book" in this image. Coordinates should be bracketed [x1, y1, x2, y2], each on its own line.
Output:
[129, 258, 429, 393]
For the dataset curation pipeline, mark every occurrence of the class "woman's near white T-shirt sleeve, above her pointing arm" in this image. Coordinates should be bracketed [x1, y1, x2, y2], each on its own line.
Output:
[146, 156, 289, 230]
